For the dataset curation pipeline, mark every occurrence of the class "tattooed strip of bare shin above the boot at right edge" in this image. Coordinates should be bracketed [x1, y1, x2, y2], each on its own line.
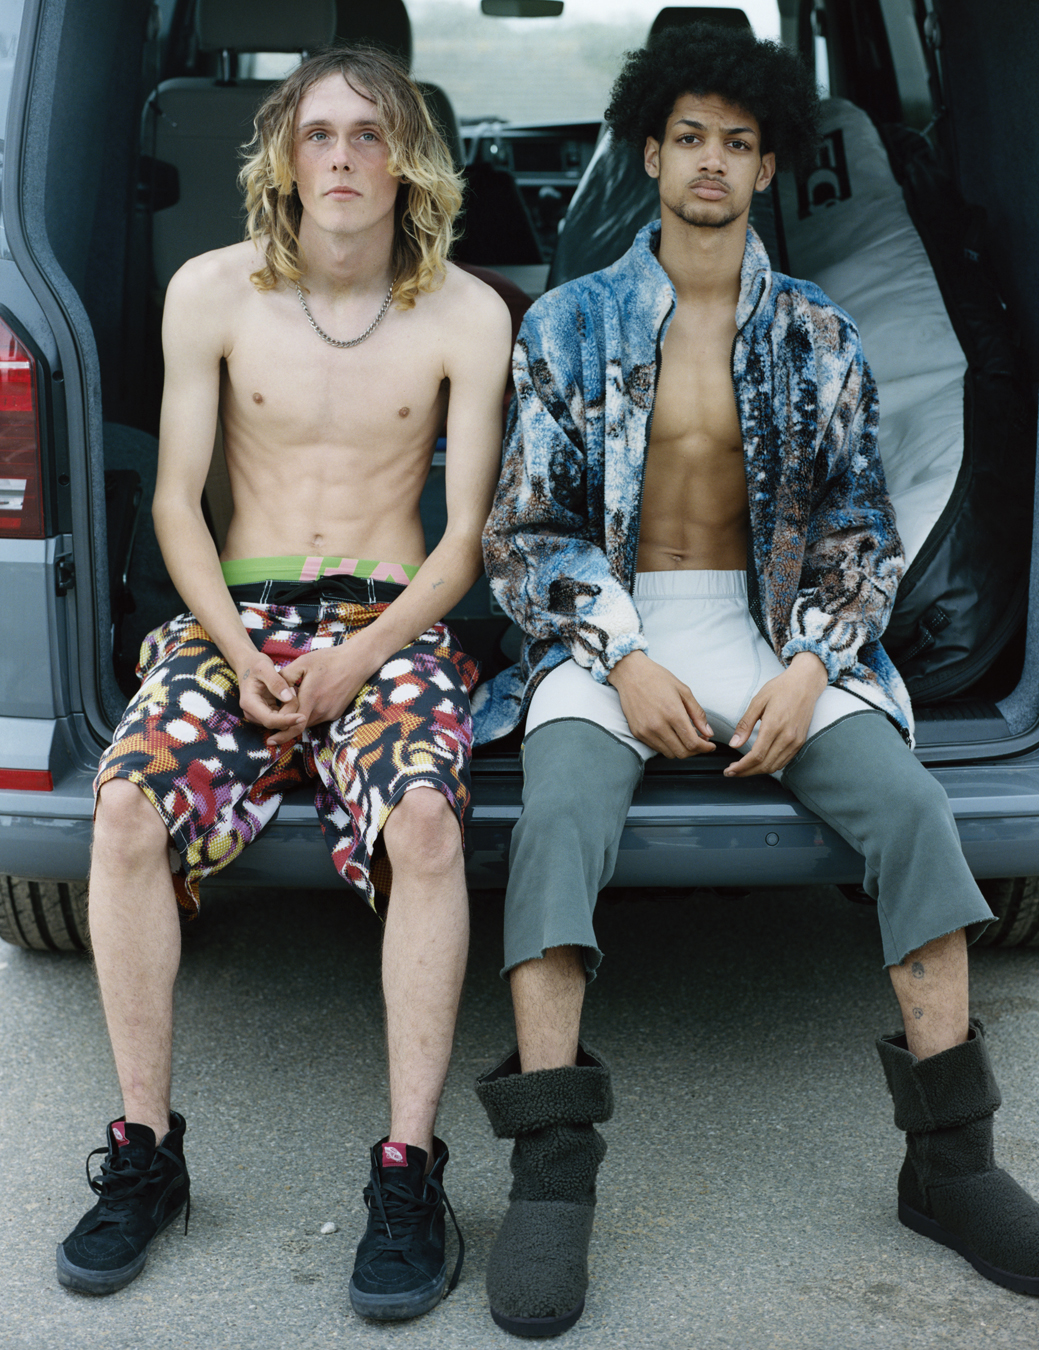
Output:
[888, 929, 967, 1060]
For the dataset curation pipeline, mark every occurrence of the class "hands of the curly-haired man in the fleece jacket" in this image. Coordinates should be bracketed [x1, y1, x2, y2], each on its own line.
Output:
[609, 652, 827, 778]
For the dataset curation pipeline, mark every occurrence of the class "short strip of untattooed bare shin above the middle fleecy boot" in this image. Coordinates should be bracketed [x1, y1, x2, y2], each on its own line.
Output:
[509, 946, 588, 1073]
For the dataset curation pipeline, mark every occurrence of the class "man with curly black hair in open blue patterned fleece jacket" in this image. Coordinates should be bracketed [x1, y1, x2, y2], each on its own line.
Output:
[475, 27, 1039, 1335]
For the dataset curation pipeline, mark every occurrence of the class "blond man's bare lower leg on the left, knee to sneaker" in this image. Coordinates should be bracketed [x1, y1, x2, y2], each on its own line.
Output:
[89, 779, 181, 1139]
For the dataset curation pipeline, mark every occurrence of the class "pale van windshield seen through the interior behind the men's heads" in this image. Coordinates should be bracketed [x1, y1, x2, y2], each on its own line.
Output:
[408, 0, 780, 122]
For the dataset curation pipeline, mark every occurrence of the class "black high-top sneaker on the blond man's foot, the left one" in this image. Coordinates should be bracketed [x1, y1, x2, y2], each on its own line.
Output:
[58, 1111, 192, 1293]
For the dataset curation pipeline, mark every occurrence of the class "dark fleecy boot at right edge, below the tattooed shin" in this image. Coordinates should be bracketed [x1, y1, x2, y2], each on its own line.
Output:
[877, 1018, 1039, 1295]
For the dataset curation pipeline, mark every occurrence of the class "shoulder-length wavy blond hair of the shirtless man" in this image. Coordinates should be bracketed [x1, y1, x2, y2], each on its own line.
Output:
[237, 47, 461, 309]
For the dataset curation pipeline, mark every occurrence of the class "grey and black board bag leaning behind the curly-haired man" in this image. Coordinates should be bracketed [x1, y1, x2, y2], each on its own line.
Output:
[779, 99, 1034, 703]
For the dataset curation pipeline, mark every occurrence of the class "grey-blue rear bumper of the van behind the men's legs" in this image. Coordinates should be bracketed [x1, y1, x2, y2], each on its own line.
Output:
[0, 755, 1039, 890]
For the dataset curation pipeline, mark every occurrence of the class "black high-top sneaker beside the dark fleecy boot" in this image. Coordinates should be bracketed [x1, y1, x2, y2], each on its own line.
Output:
[349, 1139, 466, 1322]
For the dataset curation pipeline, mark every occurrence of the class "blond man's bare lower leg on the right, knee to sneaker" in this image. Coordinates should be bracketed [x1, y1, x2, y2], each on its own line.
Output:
[382, 787, 470, 1165]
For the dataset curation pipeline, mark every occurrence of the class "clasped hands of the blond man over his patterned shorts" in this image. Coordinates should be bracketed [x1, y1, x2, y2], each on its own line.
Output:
[236, 637, 379, 749]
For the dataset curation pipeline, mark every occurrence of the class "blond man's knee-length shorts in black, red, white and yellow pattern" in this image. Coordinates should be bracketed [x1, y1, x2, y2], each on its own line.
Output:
[94, 601, 478, 917]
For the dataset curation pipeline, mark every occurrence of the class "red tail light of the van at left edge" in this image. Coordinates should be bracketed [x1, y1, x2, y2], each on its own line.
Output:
[0, 319, 43, 539]
